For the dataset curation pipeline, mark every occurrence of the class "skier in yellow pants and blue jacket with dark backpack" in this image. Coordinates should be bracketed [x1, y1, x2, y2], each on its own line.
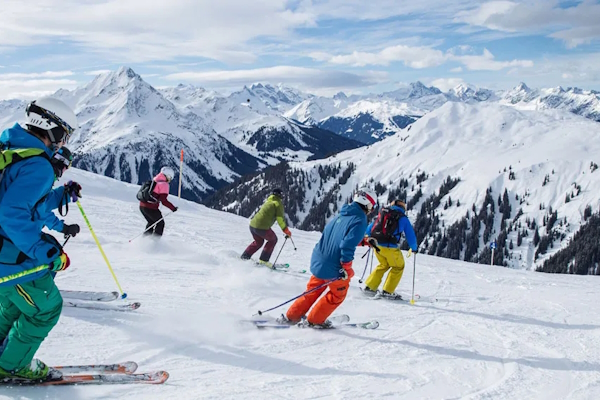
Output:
[361, 200, 417, 300]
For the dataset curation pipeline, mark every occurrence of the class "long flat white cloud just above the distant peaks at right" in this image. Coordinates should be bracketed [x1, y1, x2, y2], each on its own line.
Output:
[311, 45, 533, 71]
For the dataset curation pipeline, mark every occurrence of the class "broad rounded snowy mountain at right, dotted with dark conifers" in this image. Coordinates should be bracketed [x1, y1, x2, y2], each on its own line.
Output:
[208, 102, 600, 269]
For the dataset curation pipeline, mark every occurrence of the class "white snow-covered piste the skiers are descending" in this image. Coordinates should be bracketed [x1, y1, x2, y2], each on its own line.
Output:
[0, 170, 600, 399]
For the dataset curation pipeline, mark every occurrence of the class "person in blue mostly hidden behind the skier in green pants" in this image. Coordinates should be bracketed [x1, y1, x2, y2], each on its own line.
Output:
[44, 147, 80, 237]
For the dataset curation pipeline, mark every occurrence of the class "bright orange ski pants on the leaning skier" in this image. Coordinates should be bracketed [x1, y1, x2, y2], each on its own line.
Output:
[286, 276, 350, 324]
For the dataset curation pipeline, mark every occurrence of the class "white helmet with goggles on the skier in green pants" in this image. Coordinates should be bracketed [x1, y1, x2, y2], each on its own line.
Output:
[25, 97, 79, 144]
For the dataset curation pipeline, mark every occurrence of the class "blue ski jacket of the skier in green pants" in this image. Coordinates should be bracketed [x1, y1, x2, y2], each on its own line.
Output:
[0, 124, 62, 286]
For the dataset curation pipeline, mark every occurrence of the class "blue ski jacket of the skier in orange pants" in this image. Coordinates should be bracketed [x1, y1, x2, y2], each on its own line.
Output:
[310, 203, 367, 279]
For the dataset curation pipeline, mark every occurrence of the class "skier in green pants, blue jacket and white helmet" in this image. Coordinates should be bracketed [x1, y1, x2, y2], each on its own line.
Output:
[0, 97, 81, 381]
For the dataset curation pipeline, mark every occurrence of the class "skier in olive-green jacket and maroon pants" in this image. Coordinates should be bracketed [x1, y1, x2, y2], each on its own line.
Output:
[242, 189, 292, 268]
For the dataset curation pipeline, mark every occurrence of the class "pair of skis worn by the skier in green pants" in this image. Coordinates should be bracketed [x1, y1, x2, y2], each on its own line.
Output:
[0, 361, 169, 386]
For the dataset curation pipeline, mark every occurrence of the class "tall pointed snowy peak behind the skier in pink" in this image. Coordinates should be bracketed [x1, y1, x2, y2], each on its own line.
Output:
[51, 67, 265, 199]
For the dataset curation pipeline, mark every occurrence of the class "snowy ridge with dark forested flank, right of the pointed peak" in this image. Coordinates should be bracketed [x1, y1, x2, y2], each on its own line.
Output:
[162, 84, 362, 164]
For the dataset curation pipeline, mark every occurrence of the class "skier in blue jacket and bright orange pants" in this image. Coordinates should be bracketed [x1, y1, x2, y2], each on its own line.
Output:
[277, 189, 377, 329]
